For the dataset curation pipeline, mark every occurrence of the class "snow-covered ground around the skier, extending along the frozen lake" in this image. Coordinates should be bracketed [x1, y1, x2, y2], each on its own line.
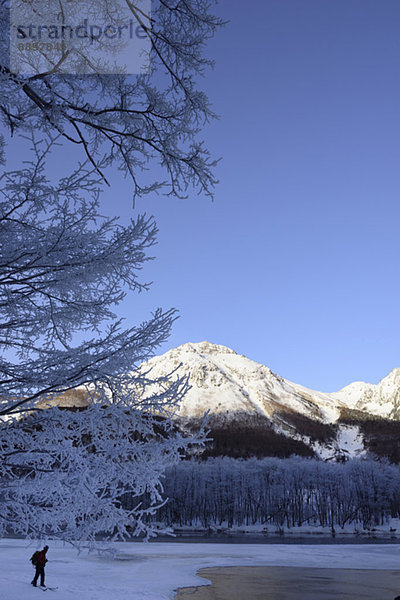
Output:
[0, 539, 400, 600]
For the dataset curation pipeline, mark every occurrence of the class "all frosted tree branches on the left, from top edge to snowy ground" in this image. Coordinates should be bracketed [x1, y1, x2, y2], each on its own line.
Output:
[0, 0, 221, 539]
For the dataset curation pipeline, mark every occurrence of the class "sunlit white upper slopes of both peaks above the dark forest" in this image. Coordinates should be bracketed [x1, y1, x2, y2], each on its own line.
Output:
[146, 342, 400, 423]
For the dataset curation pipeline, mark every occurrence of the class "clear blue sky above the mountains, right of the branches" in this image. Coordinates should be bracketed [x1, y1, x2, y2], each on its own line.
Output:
[6, 0, 400, 391]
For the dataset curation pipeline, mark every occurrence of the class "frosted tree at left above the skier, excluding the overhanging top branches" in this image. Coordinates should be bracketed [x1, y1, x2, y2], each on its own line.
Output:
[0, 138, 206, 540]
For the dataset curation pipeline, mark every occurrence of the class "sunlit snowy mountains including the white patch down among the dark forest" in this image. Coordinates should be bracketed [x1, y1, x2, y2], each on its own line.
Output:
[141, 342, 400, 458]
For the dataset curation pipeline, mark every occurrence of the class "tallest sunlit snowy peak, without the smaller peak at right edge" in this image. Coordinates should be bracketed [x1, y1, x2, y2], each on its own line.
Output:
[145, 342, 345, 423]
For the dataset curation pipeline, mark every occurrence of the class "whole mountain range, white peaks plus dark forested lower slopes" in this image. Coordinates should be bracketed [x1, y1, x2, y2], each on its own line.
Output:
[43, 341, 400, 462]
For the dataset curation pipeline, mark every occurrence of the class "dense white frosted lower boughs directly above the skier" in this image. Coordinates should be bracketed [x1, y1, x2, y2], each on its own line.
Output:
[0, 403, 203, 543]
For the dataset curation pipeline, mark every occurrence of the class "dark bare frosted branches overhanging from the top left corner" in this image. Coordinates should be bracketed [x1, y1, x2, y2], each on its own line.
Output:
[0, 0, 222, 196]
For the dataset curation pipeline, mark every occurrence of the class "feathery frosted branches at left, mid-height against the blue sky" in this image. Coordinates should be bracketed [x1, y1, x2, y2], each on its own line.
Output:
[0, 135, 180, 415]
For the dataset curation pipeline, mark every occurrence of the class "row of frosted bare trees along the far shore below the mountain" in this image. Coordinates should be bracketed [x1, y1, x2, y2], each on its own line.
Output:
[153, 458, 400, 532]
